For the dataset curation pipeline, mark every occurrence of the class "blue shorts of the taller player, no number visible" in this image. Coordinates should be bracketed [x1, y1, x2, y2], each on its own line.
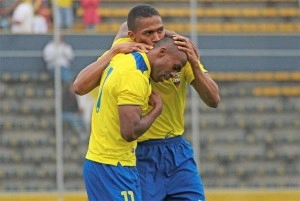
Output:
[136, 136, 205, 201]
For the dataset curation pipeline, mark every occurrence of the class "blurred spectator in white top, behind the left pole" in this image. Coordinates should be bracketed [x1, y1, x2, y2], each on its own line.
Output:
[43, 36, 74, 83]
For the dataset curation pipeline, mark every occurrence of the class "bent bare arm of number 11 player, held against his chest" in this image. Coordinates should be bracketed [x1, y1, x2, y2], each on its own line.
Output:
[119, 92, 162, 142]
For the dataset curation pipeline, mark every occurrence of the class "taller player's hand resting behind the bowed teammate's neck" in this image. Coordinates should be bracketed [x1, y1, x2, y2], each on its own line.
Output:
[111, 42, 153, 54]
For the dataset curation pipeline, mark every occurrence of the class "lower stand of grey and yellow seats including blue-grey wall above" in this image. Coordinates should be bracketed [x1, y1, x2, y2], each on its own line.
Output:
[0, 25, 300, 196]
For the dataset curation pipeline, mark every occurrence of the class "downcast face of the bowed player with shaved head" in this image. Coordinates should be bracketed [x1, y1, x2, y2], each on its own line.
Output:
[151, 53, 187, 82]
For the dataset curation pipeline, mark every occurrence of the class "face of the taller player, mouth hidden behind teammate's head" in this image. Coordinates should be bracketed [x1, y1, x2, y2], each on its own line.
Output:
[129, 16, 165, 45]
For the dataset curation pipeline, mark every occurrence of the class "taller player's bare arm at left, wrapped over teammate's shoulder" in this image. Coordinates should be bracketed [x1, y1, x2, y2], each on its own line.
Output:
[73, 42, 152, 95]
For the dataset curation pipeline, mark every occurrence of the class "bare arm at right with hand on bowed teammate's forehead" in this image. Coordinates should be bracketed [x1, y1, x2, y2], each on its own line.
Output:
[173, 35, 220, 108]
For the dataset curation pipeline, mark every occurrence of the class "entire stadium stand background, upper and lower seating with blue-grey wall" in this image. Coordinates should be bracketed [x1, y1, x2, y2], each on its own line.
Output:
[0, 0, 300, 201]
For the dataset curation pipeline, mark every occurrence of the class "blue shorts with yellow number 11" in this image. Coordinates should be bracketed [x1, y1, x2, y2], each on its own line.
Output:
[83, 159, 142, 201]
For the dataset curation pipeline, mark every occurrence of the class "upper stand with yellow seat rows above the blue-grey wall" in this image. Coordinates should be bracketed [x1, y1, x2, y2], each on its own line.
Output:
[74, 0, 300, 34]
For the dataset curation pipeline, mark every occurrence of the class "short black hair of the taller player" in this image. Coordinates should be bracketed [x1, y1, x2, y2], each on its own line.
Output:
[127, 4, 160, 31]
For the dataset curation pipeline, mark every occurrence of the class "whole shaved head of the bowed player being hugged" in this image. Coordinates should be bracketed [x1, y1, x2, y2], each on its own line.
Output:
[147, 37, 187, 82]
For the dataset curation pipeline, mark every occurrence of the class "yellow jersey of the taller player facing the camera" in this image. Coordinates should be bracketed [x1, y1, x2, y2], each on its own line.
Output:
[138, 61, 207, 141]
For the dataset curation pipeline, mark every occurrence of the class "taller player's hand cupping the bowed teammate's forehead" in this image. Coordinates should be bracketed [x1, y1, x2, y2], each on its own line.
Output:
[173, 35, 199, 63]
